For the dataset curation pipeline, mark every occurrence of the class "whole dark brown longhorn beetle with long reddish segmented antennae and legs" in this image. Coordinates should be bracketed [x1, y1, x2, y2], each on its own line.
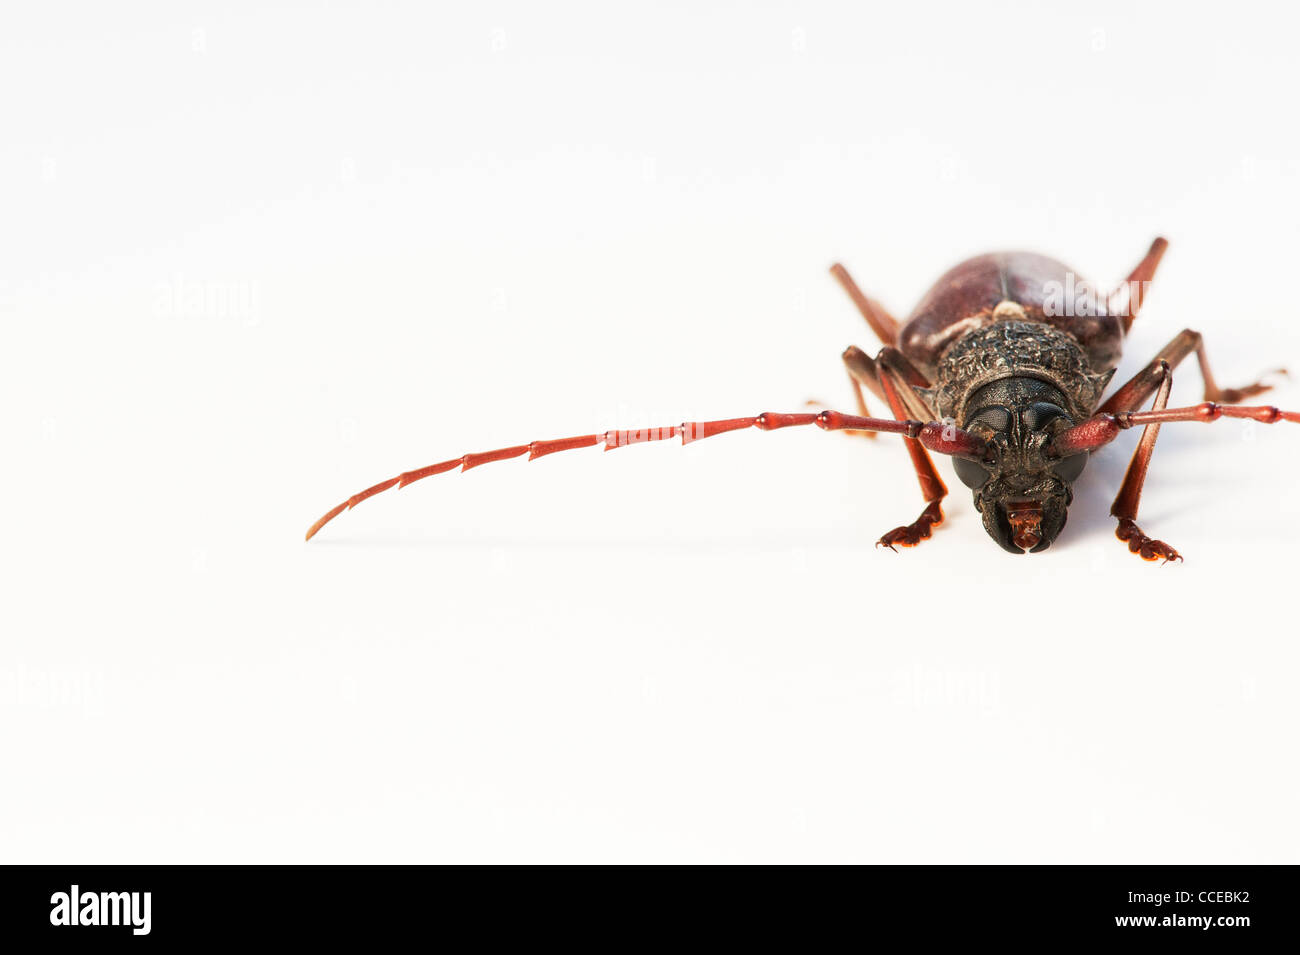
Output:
[307, 238, 1300, 563]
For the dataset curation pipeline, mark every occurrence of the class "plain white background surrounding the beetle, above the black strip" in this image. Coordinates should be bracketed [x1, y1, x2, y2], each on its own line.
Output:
[0, 3, 1300, 863]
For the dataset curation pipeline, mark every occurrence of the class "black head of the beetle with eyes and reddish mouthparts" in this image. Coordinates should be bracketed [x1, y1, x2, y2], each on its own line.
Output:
[953, 377, 1088, 554]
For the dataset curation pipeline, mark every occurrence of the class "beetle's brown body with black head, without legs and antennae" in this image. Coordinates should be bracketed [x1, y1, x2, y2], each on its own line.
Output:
[878, 252, 1125, 554]
